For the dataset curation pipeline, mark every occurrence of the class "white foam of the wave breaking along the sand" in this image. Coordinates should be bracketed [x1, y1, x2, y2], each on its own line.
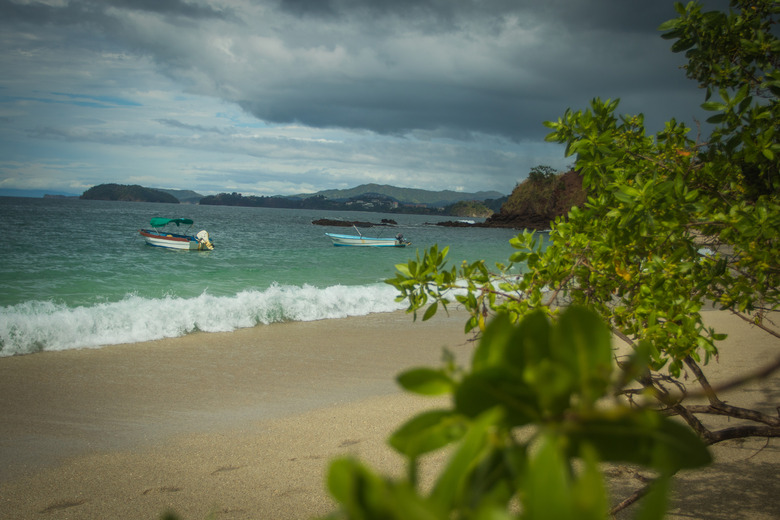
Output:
[0, 284, 404, 356]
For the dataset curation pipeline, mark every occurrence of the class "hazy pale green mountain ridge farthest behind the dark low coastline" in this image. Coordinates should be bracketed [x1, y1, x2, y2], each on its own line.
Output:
[288, 184, 506, 206]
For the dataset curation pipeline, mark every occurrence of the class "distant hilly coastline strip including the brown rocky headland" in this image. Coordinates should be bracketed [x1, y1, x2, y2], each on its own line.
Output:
[0, 171, 585, 230]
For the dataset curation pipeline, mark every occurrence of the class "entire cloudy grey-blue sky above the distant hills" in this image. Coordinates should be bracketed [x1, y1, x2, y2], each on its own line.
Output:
[0, 0, 728, 196]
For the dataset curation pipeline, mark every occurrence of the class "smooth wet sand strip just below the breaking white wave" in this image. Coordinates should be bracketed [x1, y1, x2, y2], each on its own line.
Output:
[0, 311, 469, 481]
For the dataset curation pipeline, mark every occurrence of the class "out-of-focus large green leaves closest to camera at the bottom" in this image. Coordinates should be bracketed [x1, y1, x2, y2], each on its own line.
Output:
[320, 307, 710, 520]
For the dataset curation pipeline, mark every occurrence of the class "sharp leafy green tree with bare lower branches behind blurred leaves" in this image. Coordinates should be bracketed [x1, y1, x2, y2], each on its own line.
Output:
[389, 0, 780, 450]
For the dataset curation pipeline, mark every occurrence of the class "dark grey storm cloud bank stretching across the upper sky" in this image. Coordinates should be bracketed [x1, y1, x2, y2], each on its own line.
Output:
[0, 0, 732, 140]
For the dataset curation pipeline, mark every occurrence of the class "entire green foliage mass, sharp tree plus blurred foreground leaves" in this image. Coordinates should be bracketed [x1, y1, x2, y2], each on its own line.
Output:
[322, 0, 780, 518]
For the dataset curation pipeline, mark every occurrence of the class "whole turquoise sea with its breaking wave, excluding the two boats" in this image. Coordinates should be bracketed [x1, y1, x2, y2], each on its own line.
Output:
[0, 197, 532, 356]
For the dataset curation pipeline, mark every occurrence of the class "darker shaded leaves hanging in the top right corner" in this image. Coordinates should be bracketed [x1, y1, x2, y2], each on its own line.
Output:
[660, 0, 780, 200]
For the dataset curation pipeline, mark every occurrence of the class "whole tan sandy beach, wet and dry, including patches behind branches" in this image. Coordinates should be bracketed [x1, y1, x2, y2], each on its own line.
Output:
[0, 312, 780, 519]
